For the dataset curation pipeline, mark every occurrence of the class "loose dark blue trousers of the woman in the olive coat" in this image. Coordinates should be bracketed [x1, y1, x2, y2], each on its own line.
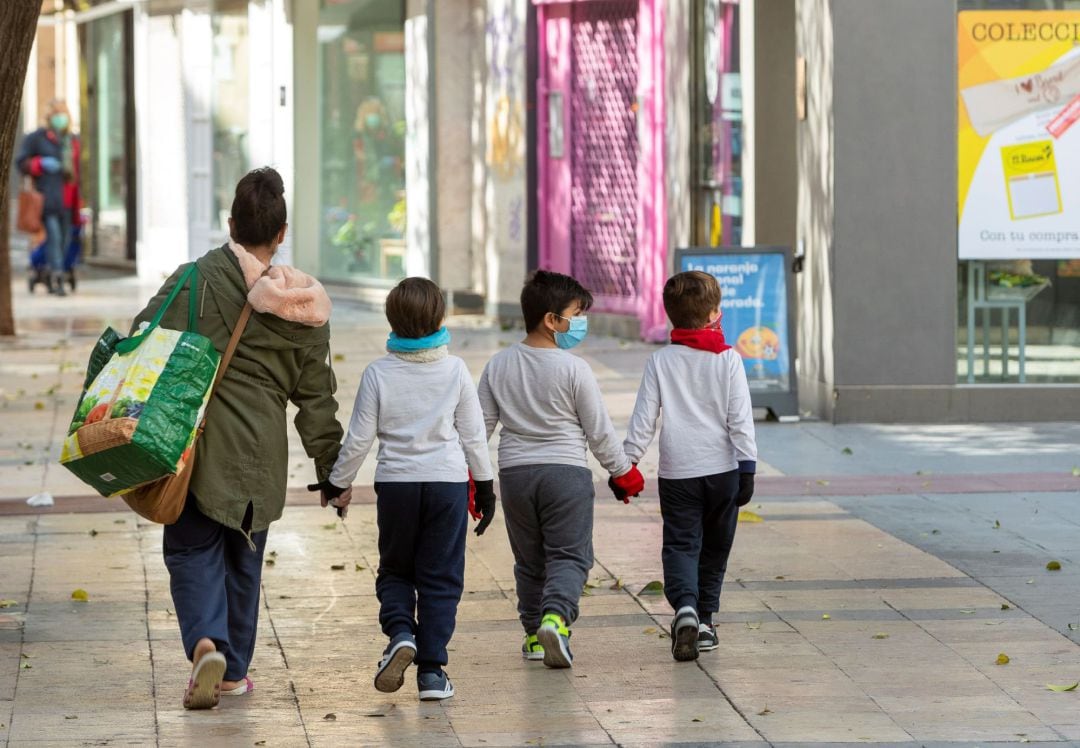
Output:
[162, 494, 267, 680]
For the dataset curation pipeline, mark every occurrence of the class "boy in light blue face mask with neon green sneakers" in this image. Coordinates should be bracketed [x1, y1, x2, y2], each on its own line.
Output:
[477, 270, 645, 667]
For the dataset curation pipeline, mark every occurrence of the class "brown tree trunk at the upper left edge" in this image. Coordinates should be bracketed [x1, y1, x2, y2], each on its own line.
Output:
[0, 0, 41, 336]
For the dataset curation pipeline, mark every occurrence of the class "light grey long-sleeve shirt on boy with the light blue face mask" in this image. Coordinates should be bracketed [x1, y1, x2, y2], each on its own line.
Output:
[477, 343, 631, 475]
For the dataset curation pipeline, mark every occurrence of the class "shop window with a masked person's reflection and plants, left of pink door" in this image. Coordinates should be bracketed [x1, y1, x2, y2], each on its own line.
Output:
[319, 0, 405, 282]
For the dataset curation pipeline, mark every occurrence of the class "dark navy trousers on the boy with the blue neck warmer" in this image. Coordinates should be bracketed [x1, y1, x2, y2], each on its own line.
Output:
[375, 482, 469, 670]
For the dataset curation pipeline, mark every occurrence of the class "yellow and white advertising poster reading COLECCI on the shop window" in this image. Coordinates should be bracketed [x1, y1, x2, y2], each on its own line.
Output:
[957, 11, 1080, 260]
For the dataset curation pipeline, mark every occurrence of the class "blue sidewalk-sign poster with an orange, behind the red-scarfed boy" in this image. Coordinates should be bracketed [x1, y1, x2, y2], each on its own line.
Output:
[679, 253, 792, 393]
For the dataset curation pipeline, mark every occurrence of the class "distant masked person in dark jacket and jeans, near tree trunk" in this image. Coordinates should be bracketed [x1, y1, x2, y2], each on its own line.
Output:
[15, 99, 79, 296]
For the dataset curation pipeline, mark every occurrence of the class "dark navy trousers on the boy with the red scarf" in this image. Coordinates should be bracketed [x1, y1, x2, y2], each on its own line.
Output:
[660, 470, 739, 620]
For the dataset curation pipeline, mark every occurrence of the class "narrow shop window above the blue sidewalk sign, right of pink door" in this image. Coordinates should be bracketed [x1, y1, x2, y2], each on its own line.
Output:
[691, 0, 743, 246]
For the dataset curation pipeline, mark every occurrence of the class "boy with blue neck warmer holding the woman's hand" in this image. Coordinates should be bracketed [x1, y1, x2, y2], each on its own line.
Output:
[323, 277, 495, 701]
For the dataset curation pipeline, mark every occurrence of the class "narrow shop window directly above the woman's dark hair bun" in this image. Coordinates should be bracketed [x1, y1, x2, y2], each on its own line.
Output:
[211, 0, 251, 236]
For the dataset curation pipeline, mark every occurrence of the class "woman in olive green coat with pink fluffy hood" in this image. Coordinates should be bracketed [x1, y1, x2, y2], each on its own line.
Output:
[134, 167, 349, 709]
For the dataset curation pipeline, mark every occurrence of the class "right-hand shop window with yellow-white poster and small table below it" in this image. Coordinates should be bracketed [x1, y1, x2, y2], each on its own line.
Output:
[957, 0, 1080, 383]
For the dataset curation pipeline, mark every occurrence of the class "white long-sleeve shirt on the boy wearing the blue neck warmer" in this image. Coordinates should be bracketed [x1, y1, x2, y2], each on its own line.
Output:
[329, 355, 494, 487]
